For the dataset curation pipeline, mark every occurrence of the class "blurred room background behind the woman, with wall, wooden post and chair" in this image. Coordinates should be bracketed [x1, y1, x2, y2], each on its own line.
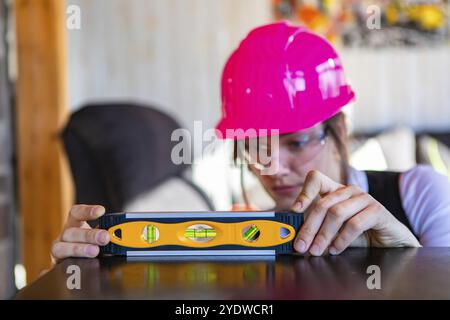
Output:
[0, 0, 450, 298]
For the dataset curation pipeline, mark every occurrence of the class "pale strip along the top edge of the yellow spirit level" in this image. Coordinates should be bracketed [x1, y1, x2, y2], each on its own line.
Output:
[125, 211, 275, 219]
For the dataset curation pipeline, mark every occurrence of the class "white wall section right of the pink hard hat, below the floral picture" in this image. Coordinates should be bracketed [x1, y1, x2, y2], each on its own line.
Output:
[339, 46, 450, 131]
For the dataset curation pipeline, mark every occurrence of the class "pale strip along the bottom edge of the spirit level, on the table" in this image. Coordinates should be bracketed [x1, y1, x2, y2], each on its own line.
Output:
[127, 250, 275, 257]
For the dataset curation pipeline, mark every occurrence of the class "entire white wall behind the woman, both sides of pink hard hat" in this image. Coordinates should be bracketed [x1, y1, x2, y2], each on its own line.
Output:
[67, 0, 450, 135]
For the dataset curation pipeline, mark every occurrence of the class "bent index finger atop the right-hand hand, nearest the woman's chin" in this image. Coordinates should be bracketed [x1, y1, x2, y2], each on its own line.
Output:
[292, 170, 343, 212]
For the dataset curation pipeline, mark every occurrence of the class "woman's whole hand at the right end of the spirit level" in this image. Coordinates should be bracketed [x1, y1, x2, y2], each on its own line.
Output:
[293, 171, 420, 256]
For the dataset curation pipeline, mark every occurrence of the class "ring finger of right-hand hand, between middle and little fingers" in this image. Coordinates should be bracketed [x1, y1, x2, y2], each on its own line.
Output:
[310, 194, 371, 256]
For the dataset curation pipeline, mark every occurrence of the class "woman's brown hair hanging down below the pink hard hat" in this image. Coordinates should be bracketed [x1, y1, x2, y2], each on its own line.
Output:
[233, 112, 348, 206]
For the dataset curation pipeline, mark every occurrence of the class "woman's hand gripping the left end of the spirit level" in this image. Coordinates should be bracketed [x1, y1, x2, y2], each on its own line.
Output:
[51, 204, 110, 262]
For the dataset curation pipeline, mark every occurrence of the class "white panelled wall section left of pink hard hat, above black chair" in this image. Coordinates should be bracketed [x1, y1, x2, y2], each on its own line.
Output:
[67, 0, 271, 135]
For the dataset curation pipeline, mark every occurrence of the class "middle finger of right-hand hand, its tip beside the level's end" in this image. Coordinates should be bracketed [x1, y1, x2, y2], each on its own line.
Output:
[294, 186, 360, 254]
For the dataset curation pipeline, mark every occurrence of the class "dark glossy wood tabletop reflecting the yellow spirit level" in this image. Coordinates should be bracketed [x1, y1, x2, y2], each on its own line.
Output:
[16, 248, 450, 300]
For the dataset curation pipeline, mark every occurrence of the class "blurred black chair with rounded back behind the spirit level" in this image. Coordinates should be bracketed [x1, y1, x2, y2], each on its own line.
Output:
[62, 103, 214, 212]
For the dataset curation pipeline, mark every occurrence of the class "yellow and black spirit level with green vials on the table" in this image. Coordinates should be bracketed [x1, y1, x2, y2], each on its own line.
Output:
[99, 211, 303, 256]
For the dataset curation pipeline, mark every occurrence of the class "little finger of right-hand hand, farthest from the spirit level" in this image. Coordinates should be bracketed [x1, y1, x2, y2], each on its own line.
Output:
[329, 204, 379, 254]
